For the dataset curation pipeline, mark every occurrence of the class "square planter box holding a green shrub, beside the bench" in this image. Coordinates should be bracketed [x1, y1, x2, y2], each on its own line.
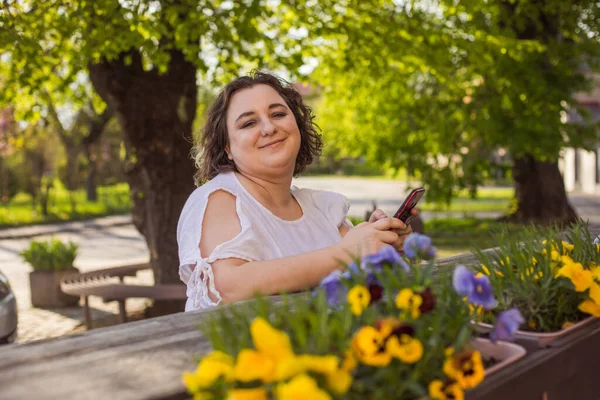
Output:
[29, 268, 79, 308]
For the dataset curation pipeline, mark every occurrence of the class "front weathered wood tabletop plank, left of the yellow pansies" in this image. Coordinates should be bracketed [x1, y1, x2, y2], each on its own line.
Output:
[0, 331, 210, 400]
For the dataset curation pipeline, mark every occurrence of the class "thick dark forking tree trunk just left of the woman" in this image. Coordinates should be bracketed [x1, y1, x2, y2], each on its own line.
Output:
[90, 50, 197, 312]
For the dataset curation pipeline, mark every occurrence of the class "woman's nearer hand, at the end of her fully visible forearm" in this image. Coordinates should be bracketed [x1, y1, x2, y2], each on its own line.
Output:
[339, 217, 406, 257]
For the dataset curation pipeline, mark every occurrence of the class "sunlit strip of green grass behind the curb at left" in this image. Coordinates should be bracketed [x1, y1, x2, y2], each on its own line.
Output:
[0, 183, 131, 228]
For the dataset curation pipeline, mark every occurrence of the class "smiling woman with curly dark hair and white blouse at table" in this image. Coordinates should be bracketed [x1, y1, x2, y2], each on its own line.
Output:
[177, 73, 411, 311]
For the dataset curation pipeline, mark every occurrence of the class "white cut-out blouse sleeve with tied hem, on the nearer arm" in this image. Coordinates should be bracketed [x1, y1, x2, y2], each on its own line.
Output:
[177, 188, 260, 311]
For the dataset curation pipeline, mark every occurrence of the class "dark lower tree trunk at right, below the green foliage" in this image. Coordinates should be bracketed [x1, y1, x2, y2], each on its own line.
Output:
[509, 154, 577, 225]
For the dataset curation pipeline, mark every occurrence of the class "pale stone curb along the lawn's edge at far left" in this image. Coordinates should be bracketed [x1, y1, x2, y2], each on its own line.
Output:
[0, 214, 133, 240]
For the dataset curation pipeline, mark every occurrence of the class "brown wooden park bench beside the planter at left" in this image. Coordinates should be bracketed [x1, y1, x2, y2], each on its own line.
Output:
[60, 263, 186, 329]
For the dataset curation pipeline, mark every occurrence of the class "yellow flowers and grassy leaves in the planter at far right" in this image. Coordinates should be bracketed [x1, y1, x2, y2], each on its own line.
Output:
[475, 222, 600, 332]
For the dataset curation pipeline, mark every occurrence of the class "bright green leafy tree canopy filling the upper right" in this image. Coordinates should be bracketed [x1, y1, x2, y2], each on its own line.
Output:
[316, 1, 600, 219]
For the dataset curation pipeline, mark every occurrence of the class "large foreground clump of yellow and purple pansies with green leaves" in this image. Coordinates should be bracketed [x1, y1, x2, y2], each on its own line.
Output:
[183, 234, 518, 400]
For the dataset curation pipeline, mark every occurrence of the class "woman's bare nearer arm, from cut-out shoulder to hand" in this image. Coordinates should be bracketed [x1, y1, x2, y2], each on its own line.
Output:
[200, 191, 401, 303]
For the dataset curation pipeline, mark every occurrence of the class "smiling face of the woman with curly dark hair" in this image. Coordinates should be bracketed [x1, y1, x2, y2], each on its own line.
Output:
[226, 84, 300, 176]
